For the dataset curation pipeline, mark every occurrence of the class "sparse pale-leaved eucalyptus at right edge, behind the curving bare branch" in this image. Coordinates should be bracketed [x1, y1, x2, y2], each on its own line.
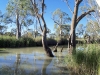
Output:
[81, 0, 100, 38]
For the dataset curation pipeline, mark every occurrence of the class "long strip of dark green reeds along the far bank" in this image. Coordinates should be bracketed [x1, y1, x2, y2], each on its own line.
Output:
[0, 35, 84, 48]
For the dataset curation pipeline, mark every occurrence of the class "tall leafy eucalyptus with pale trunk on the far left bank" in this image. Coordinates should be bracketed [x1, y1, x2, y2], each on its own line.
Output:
[6, 0, 32, 39]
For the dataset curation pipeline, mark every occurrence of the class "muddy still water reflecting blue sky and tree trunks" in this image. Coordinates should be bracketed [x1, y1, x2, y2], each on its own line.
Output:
[0, 47, 68, 75]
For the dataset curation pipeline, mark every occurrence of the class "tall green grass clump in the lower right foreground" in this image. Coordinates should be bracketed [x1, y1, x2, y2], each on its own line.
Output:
[65, 44, 100, 75]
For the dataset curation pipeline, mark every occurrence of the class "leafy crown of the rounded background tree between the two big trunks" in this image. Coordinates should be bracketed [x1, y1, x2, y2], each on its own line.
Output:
[52, 8, 71, 36]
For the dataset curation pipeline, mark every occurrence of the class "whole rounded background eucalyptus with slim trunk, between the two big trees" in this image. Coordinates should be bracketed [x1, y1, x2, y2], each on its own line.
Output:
[52, 8, 71, 38]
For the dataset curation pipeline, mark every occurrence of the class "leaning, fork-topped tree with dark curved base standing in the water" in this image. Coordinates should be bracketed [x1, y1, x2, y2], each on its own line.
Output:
[30, 0, 54, 57]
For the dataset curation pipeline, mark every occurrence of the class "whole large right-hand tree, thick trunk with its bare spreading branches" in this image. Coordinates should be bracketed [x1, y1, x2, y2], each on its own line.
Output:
[64, 0, 94, 53]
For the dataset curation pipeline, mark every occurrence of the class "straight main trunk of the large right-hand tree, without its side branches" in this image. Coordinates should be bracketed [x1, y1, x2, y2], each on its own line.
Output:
[68, 0, 80, 48]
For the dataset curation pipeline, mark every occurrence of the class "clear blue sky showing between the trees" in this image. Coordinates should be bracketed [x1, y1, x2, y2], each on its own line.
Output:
[0, 0, 86, 32]
